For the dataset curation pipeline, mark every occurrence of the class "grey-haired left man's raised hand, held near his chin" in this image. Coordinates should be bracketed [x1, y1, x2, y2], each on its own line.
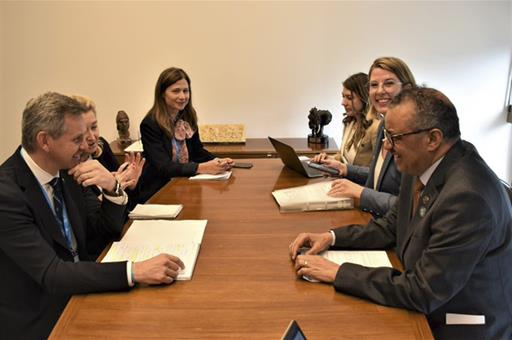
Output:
[68, 159, 116, 192]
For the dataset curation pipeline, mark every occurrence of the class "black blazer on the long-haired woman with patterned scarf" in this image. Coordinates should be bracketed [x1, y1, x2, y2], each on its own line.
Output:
[139, 116, 215, 203]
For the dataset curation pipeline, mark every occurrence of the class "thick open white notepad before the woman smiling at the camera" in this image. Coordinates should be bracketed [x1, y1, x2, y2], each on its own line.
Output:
[272, 181, 354, 212]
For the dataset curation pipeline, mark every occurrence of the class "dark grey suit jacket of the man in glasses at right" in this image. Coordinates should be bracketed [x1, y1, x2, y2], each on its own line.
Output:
[334, 141, 512, 339]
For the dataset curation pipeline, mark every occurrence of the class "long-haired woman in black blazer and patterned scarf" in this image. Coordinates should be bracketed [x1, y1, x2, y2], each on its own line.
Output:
[139, 67, 233, 202]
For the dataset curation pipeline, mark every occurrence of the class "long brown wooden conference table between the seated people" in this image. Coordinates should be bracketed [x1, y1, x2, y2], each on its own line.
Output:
[51, 159, 432, 339]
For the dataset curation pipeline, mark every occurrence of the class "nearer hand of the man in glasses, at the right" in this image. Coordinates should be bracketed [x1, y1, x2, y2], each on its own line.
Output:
[295, 255, 340, 282]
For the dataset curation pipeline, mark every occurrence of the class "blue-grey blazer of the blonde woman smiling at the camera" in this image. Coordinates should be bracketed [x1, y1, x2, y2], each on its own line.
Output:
[347, 122, 401, 217]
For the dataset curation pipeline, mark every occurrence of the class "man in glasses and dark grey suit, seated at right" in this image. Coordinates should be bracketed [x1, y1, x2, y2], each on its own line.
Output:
[290, 88, 512, 339]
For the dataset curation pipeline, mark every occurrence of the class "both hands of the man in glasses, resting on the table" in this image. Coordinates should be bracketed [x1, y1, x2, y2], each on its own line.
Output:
[289, 232, 339, 282]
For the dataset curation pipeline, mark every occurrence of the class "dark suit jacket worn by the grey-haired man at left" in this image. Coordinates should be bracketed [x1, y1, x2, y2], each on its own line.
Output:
[0, 149, 128, 339]
